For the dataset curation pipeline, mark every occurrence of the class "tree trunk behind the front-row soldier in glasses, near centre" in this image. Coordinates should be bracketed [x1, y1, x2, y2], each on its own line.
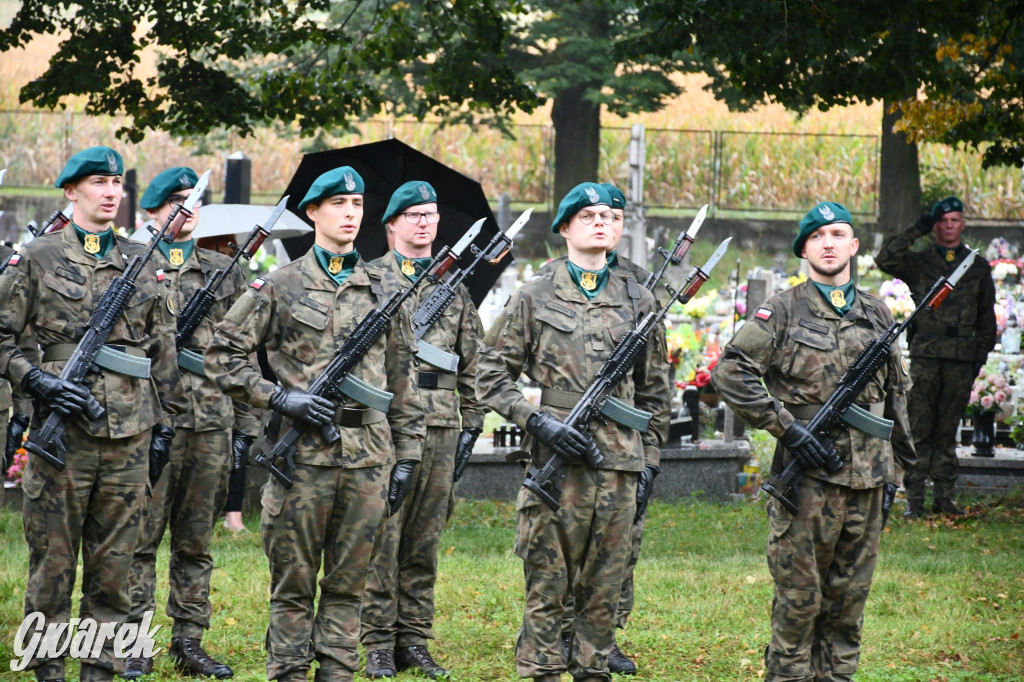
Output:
[551, 85, 601, 202]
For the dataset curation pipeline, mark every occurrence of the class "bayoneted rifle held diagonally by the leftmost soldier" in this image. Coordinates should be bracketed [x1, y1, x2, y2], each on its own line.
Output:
[25, 166, 210, 471]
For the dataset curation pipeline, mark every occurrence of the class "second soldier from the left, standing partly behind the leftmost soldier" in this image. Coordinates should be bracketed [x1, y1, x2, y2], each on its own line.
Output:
[124, 167, 259, 679]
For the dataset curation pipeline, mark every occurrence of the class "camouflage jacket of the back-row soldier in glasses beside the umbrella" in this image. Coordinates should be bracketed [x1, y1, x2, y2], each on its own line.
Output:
[372, 251, 486, 429]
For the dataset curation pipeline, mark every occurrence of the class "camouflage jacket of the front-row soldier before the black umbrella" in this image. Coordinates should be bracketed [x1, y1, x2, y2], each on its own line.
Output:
[205, 249, 425, 468]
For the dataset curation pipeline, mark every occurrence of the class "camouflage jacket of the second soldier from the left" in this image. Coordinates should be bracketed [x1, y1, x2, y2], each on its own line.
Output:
[152, 247, 259, 436]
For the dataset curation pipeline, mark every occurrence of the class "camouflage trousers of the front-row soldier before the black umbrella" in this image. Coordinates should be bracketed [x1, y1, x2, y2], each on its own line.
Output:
[261, 464, 391, 682]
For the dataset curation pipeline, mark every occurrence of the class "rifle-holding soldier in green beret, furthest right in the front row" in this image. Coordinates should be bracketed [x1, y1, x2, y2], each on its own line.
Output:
[712, 202, 915, 681]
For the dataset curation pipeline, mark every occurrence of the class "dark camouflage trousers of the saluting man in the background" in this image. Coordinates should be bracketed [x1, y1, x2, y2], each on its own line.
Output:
[903, 357, 975, 505]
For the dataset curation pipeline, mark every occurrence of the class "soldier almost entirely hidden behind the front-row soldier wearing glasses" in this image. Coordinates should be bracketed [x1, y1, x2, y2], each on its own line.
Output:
[540, 182, 672, 675]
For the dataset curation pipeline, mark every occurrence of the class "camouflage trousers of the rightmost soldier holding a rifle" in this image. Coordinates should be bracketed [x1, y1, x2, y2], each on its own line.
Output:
[765, 477, 882, 682]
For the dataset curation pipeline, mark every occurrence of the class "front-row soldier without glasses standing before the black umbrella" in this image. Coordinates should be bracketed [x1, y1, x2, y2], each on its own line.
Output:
[205, 166, 424, 682]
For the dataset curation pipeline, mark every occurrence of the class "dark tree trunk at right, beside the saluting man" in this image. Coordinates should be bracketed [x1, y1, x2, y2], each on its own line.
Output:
[877, 100, 921, 235]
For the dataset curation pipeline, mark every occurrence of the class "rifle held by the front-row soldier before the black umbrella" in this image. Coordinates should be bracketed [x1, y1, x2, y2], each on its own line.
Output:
[253, 236, 466, 488]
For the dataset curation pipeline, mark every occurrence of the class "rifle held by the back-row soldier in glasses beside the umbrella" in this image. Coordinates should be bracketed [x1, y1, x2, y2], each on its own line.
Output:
[413, 208, 534, 372]
